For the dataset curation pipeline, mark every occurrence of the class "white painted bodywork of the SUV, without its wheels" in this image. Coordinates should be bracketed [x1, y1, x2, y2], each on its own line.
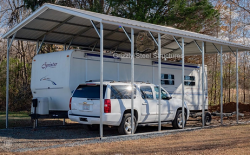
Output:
[68, 82, 189, 126]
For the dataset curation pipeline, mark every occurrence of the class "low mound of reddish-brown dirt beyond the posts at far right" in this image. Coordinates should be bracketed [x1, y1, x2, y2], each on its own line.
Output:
[209, 102, 250, 113]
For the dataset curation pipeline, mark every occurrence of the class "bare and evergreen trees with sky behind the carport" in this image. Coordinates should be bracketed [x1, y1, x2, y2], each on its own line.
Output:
[0, 0, 250, 111]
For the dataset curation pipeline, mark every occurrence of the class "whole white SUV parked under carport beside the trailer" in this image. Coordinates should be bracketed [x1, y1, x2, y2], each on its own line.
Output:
[68, 81, 189, 134]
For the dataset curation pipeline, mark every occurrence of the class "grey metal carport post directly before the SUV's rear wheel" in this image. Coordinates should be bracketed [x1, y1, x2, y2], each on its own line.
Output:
[131, 28, 134, 134]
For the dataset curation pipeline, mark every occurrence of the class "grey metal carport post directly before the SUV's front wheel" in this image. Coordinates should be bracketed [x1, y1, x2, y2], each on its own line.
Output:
[181, 37, 185, 129]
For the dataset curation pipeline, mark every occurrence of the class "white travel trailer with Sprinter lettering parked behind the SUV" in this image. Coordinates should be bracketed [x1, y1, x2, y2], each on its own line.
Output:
[31, 50, 208, 117]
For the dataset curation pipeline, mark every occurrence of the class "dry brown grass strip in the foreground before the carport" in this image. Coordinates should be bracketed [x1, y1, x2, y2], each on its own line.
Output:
[23, 125, 250, 155]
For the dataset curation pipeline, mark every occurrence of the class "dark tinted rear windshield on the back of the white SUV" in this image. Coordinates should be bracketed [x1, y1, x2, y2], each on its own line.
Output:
[72, 85, 107, 99]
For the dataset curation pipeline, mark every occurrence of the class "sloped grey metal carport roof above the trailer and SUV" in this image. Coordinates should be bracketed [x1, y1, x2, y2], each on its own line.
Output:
[3, 3, 250, 55]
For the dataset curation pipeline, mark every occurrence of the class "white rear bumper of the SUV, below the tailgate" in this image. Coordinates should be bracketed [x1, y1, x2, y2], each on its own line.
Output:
[68, 110, 121, 126]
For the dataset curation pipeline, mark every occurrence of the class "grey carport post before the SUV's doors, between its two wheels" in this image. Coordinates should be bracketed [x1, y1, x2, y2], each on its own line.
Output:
[158, 33, 161, 131]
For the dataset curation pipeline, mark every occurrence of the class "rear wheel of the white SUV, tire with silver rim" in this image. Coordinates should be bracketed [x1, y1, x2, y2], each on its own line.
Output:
[118, 113, 137, 135]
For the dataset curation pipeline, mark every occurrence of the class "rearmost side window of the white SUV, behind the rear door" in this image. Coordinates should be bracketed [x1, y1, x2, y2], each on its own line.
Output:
[110, 85, 136, 99]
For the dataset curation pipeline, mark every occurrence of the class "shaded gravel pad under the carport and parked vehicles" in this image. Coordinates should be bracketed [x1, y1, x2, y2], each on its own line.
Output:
[0, 113, 250, 152]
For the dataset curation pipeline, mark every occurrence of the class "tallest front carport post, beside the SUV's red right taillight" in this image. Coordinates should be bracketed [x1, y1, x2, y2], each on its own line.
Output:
[97, 23, 104, 139]
